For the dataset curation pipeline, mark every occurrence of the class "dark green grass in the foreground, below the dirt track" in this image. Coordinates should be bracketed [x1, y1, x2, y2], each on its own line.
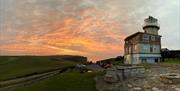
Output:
[12, 71, 97, 91]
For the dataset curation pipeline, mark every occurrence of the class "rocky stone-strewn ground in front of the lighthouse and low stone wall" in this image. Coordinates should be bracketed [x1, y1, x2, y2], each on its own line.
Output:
[97, 64, 180, 91]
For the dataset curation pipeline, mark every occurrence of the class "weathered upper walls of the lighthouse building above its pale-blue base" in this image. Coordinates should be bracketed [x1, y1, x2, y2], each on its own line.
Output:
[124, 33, 161, 55]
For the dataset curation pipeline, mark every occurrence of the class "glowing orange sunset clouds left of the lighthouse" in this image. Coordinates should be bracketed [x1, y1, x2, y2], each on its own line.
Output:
[0, 2, 125, 60]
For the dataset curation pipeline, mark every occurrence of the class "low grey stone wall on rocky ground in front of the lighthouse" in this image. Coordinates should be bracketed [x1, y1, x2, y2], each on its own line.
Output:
[104, 66, 145, 83]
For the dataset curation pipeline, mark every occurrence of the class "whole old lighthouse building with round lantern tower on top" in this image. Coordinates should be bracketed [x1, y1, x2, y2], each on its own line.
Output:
[124, 16, 161, 64]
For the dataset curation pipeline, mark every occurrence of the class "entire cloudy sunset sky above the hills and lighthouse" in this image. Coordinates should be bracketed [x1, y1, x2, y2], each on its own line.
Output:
[0, 0, 180, 61]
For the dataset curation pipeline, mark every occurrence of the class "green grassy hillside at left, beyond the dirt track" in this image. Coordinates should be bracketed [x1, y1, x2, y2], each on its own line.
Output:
[0, 56, 84, 80]
